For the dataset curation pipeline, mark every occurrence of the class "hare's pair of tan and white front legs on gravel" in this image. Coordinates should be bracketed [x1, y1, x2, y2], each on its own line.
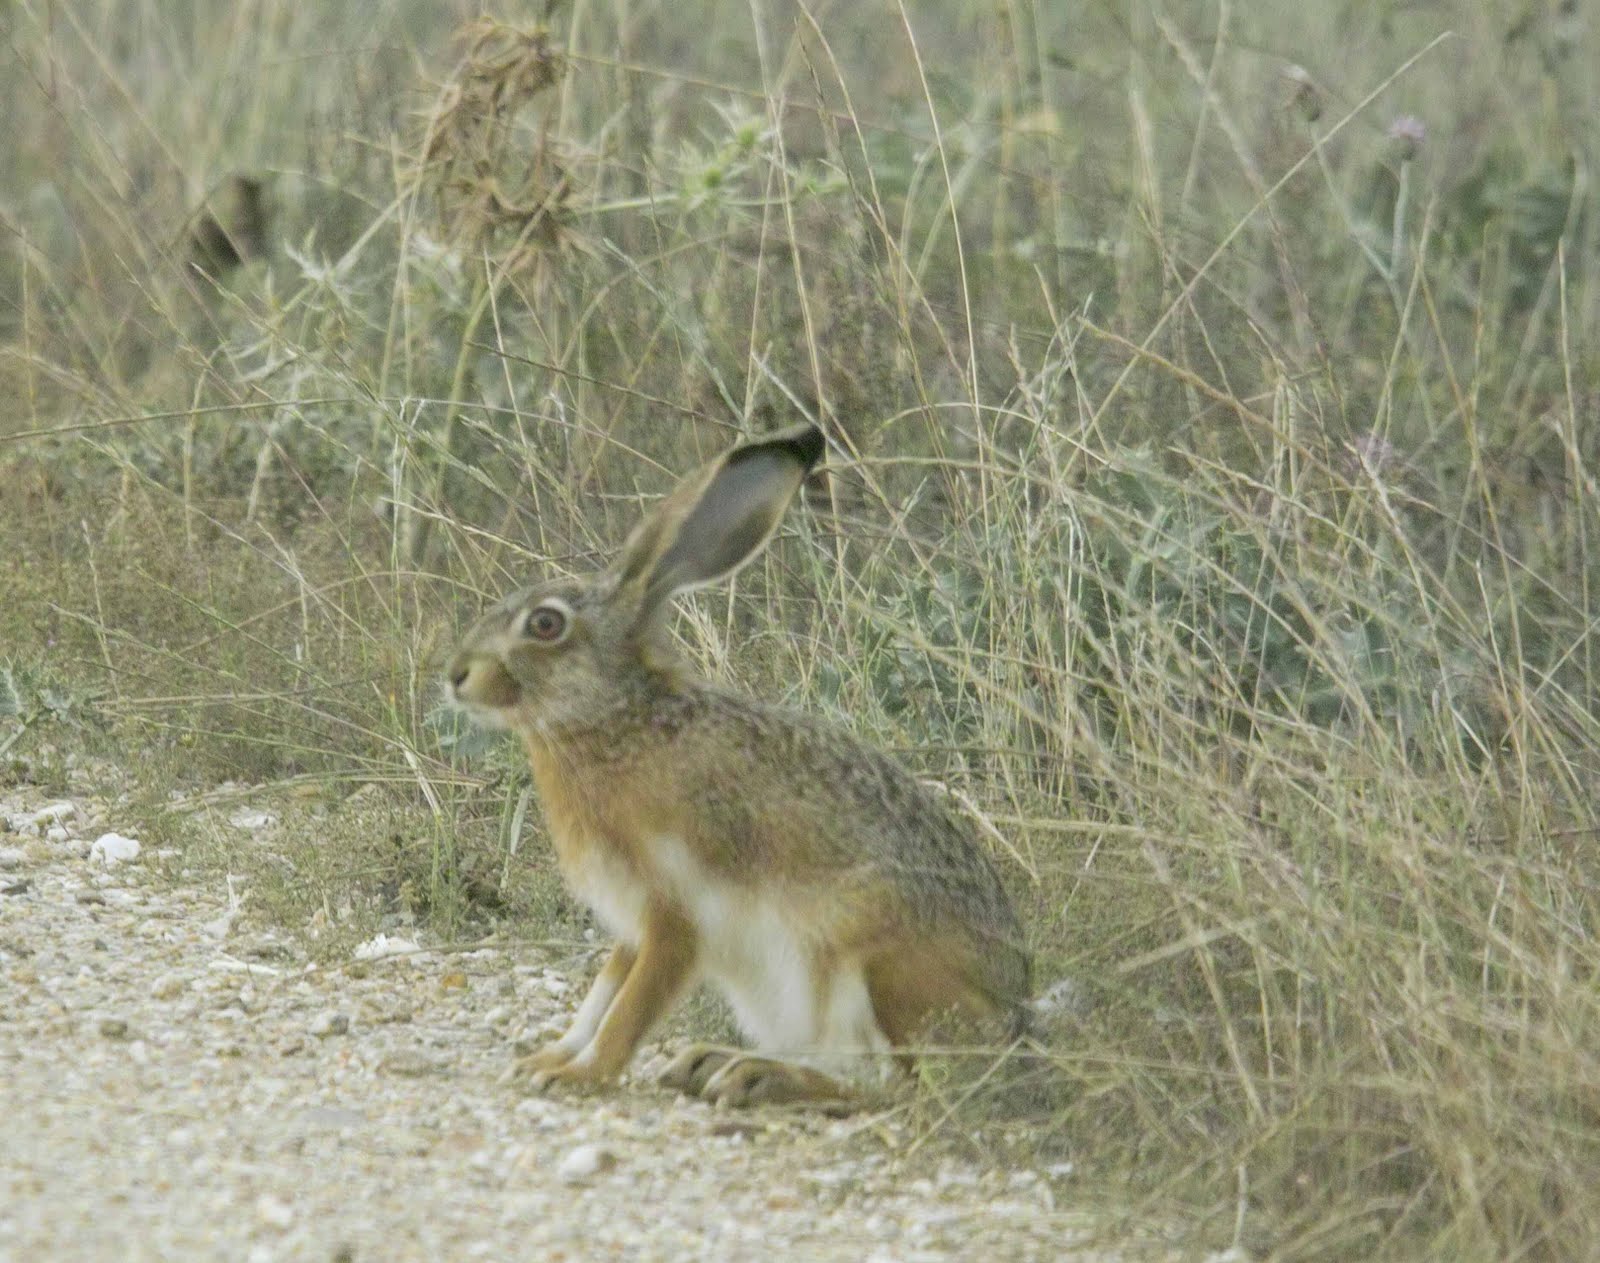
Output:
[514, 904, 699, 1089]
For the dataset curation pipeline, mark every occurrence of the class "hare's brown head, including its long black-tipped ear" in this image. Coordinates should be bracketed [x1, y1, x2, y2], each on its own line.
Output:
[446, 426, 824, 733]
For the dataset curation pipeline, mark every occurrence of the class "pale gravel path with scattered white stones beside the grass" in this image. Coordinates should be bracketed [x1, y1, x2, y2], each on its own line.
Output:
[0, 788, 1132, 1263]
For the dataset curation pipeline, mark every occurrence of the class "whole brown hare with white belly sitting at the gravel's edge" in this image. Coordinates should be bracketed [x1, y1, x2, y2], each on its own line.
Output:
[448, 426, 1029, 1105]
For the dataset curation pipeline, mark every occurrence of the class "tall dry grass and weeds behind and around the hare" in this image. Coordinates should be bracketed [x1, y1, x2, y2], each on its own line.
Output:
[0, 0, 1600, 1260]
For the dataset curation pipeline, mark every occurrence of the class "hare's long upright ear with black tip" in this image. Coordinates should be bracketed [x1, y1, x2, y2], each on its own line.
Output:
[613, 426, 826, 616]
